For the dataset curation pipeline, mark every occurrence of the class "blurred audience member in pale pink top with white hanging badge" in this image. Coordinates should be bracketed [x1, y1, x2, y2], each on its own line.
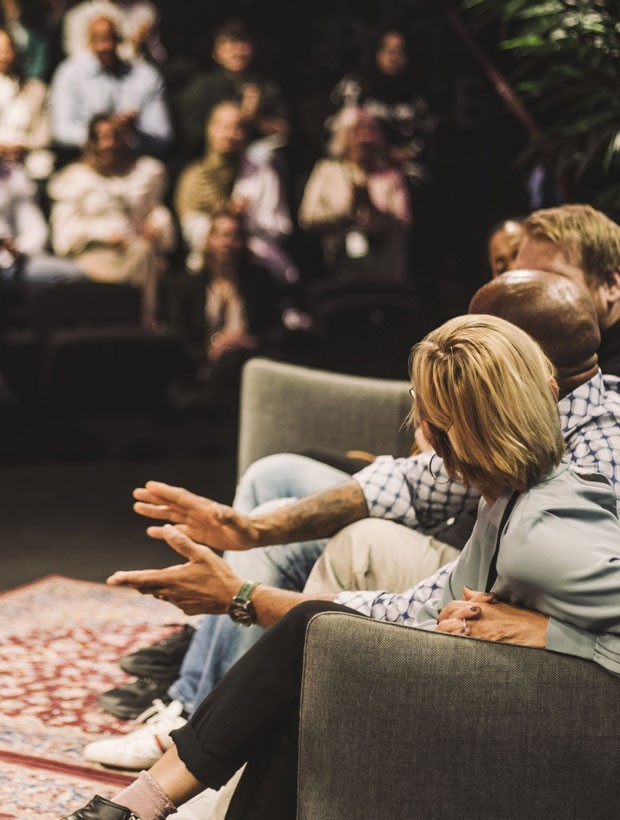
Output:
[298, 107, 411, 281]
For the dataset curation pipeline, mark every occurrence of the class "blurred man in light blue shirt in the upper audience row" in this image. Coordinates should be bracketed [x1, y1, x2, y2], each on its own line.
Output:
[50, 17, 173, 157]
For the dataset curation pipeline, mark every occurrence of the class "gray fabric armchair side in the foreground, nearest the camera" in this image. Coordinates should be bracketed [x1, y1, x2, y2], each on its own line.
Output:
[297, 613, 620, 820]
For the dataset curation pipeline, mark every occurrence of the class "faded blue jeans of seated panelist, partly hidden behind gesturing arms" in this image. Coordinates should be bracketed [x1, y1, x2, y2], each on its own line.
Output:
[168, 453, 350, 715]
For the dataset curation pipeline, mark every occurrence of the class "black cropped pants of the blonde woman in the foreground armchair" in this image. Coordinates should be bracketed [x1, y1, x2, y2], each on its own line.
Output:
[172, 601, 360, 820]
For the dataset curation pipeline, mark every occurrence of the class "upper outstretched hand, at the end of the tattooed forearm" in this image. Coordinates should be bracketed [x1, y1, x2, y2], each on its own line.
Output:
[133, 481, 258, 550]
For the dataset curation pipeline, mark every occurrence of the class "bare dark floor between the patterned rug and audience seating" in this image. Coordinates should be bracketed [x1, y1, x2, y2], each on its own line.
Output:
[0, 400, 237, 589]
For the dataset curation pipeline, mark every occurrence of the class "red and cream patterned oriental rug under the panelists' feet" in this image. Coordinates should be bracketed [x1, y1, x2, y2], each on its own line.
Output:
[0, 575, 196, 820]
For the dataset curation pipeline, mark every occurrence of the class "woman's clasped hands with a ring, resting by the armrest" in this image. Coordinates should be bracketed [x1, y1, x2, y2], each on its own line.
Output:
[436, 587, 549, 648]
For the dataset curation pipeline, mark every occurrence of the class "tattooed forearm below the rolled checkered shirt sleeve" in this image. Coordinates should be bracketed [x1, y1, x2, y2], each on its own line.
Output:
[253, 479, 368, 546]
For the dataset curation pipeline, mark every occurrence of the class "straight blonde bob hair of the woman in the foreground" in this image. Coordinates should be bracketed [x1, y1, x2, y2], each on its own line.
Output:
[409, 314, 564, 492]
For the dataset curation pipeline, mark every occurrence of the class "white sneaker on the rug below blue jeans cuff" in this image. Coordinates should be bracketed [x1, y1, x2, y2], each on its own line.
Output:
[83, 700, 187, 770]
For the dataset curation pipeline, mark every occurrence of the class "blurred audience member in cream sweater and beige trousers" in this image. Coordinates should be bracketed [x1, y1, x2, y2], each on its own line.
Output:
[48, 114, 176, 329]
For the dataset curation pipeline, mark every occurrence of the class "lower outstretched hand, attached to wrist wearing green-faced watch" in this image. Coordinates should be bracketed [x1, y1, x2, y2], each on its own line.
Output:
[107, 524, 243, 615]
